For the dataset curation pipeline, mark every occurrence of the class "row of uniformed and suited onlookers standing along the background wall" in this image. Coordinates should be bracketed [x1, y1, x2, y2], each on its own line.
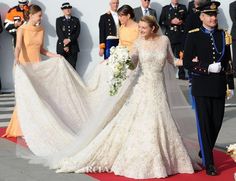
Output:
[0, 0, 236, 89]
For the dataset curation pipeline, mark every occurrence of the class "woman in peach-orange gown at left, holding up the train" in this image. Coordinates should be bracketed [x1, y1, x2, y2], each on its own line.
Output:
[3, 5, 60, 137]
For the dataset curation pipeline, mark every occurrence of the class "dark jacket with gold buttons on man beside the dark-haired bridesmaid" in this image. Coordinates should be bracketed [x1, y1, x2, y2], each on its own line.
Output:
[98, 12, 117, 59]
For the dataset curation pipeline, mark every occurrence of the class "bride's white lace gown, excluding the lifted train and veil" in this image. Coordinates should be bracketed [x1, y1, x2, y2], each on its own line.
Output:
[53, 36, 193, 178]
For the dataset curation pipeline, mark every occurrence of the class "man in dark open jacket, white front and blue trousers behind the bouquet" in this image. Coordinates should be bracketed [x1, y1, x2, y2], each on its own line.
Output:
[99, 0, 119, 59]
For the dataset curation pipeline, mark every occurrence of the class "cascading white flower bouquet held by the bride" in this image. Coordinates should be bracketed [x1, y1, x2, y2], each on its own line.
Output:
[107, 46, 132, 96]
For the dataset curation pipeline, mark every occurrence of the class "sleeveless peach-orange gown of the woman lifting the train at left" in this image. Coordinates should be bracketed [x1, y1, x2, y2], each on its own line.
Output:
[3, 24, 44, 137]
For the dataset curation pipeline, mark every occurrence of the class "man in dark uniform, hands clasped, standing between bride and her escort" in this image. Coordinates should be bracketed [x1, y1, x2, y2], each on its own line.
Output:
[159, 0, 187, 79]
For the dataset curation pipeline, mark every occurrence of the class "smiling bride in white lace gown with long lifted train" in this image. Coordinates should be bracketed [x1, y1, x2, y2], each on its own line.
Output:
[15, 5, 199, 179]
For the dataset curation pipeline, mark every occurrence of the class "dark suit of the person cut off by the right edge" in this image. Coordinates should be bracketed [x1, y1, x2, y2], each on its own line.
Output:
[229, 1, 236, 76]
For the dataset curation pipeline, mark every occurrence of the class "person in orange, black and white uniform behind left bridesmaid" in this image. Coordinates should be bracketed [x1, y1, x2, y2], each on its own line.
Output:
[4, 0, 29, 47]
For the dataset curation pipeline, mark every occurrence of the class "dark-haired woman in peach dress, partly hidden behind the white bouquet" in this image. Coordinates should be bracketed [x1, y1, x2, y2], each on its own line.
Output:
[117, 5, 138, 50]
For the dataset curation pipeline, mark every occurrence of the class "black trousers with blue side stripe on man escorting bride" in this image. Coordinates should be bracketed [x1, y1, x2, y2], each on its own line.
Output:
[195, 96, 225, 166]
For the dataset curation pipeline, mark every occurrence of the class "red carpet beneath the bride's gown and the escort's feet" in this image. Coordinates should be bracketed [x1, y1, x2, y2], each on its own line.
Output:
[0, 128, 236, 181]
